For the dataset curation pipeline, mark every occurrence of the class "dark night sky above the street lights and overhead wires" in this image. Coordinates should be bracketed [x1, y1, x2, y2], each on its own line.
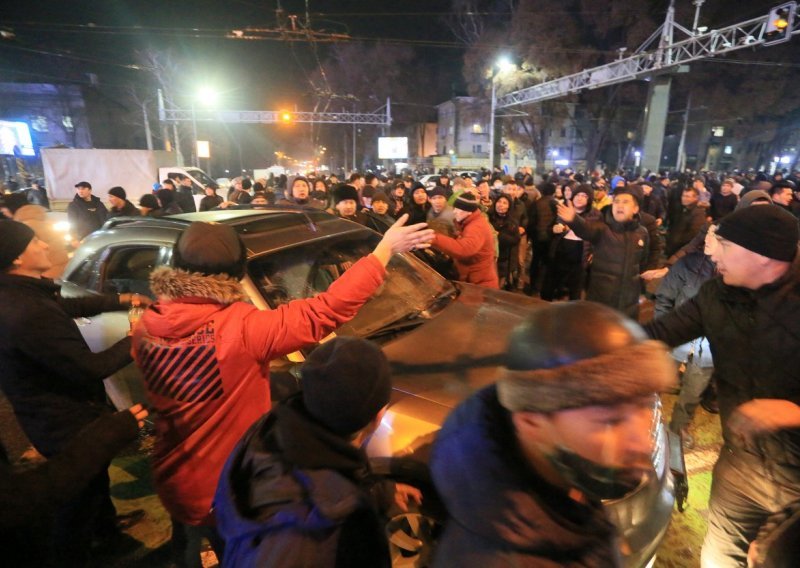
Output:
[0, 0, 463, 108]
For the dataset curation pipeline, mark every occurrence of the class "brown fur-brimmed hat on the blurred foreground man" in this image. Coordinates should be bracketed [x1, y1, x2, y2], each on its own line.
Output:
[497, 301, 677, 413]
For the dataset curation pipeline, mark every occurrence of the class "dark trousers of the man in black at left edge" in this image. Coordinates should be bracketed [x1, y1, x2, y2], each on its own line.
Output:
[50, 466, 116, 566]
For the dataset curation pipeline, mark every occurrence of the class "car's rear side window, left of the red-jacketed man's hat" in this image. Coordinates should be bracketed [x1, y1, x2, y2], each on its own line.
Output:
[101, 247, 161, 298]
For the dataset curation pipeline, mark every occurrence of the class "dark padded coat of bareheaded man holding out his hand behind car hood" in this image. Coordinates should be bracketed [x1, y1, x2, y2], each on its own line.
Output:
[569, 210, 650, 320]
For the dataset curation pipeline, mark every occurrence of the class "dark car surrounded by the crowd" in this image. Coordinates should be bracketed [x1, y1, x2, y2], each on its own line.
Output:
[62, 208, 679, 566]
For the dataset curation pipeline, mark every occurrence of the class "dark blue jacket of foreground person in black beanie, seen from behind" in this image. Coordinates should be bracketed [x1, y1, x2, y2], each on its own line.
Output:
[214, 397, 394, 568]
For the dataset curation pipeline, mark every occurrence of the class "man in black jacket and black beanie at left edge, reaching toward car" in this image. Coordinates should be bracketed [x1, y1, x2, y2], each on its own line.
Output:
[0, 221, 145, 565]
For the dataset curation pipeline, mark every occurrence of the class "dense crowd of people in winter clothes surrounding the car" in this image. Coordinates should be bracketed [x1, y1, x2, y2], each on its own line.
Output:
[0, 162, 800, 568]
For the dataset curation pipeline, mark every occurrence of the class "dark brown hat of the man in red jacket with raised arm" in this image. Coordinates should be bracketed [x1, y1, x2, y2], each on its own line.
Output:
[172, 221, 247, 279]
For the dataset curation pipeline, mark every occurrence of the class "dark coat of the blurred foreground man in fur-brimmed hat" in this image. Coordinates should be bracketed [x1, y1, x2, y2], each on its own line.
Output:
[431, 385, 620, 568]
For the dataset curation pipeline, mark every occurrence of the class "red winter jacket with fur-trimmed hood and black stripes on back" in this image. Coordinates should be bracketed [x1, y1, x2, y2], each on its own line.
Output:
[132, 255, 386, 525]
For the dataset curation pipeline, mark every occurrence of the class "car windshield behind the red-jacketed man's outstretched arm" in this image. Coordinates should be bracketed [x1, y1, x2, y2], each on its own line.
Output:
[248, 233, 456, 337]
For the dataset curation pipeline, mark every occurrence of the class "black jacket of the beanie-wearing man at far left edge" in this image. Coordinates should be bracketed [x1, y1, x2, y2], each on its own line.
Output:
[0, 274, 132, 457]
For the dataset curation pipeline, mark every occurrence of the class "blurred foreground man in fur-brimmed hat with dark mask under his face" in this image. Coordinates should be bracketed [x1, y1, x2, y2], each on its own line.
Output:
[431, 301, 675, 568]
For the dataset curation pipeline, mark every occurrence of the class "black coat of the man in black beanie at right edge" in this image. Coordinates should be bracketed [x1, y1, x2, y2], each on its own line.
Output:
[645, 254, 800, 478]
